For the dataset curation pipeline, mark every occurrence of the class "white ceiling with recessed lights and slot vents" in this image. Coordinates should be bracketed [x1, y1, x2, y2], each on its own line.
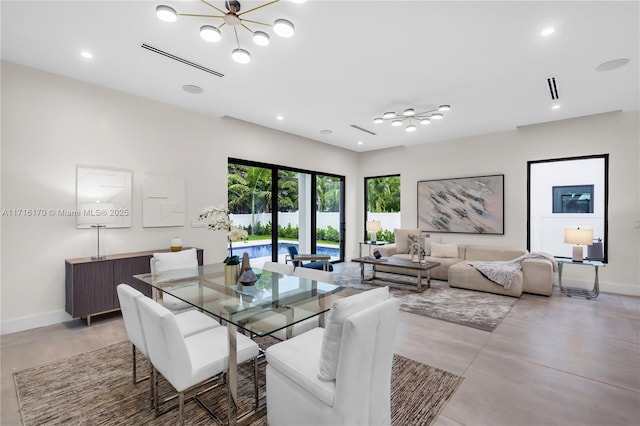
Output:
[1, 0, 640, 151]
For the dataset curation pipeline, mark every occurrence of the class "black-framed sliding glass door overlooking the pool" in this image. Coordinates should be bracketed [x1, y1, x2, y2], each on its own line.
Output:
[228, 159, 344, 267]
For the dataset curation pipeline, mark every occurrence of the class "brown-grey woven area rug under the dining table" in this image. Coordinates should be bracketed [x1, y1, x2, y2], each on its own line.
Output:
[14, 342, 462, 426]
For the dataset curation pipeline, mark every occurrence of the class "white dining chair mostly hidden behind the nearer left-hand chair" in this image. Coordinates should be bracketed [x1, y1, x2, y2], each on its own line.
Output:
[116, 283, 220, 402]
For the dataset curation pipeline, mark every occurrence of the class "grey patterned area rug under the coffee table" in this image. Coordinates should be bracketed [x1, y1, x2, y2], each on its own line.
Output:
[334, 264, 518, 331]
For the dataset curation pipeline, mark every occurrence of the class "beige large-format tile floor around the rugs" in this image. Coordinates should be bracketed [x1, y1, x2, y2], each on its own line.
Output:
[0, 264, 640, 426]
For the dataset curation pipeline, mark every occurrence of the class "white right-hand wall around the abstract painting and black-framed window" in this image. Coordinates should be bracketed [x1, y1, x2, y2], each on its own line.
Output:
[358, 111, 640, 295]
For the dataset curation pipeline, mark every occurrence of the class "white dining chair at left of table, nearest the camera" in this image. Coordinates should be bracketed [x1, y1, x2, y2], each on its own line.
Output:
[136, 297, 258, 424]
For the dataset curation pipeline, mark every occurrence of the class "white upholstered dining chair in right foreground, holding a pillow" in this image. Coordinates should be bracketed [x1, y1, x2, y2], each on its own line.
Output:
[266, 287, 399, 426]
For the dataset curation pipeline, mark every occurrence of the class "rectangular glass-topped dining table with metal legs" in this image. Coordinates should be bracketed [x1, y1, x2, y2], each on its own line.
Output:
[133, 263, 353, 425]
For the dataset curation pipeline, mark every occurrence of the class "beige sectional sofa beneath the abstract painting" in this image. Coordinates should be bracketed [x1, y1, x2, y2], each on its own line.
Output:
[376, 229, 556, 297]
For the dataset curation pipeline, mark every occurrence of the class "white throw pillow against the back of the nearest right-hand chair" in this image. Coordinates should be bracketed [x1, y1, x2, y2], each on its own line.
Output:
[318, 287, 389, 380]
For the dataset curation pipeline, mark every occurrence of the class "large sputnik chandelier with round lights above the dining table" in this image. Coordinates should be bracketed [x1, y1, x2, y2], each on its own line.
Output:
[156, 0, 305, 64]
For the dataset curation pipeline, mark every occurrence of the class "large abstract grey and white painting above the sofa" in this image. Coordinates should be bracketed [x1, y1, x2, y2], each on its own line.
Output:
[418, 175, 504, 234]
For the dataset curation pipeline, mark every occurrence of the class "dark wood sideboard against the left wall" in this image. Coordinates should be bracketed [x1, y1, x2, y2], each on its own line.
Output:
[64, 249, 204, 325]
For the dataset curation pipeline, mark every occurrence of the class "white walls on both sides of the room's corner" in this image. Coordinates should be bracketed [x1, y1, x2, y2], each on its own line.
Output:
[0, 62, 640, 333]
